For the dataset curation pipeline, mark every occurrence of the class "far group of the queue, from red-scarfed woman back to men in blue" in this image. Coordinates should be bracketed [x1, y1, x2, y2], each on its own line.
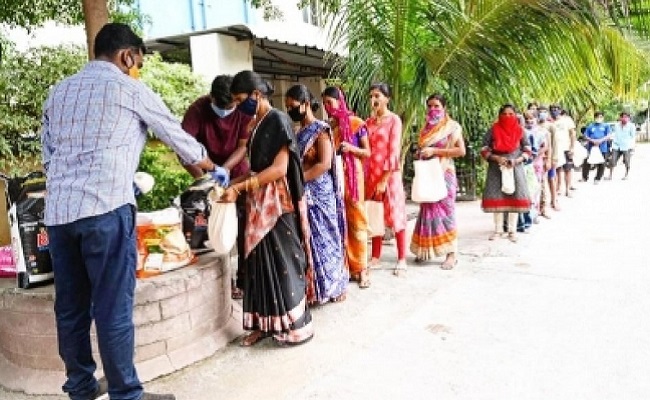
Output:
[481, 104, 636, 243]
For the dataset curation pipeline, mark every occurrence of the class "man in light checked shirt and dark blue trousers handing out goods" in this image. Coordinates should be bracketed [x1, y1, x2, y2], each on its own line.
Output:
[41, 23, 219, 400]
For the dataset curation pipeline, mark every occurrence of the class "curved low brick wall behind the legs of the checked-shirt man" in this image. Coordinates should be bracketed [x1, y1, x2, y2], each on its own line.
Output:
[0, 254, 242, 394]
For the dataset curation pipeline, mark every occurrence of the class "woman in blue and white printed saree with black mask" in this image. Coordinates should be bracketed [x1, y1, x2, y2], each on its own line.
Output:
[285, 85, 349, 304]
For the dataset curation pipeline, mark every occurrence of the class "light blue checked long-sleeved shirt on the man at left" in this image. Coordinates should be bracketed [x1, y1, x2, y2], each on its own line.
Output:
[41, 61, 207, 225]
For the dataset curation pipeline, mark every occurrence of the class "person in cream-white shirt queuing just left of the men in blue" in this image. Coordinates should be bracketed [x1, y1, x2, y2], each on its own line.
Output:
[550, 105, 576, 197]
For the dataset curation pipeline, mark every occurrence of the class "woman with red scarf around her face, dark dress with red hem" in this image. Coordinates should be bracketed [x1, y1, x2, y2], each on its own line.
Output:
[481, 104, 532, 243]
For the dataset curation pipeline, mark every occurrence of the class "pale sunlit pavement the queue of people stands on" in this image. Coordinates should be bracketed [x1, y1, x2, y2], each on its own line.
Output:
[5, 145, 650, 400]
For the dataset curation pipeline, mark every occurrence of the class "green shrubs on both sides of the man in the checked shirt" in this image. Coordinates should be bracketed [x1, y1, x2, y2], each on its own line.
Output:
[0, 41, 208, 211]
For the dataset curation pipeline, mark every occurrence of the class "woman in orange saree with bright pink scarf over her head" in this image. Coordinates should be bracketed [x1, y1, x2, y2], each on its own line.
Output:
[321, 86, 370, 289]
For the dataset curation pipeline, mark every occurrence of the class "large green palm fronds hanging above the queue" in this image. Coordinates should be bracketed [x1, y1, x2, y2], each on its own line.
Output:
[331, 0, 650, 150]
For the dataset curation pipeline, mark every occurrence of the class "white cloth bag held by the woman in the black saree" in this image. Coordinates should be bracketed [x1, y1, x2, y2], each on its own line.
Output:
[208, 190, 237, 255]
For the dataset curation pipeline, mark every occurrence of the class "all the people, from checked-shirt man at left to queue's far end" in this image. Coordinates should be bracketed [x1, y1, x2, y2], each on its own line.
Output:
[42, 23, 634, 400]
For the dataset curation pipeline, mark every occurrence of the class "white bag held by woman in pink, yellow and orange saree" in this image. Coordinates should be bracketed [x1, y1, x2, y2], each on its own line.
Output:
[411, 157, 448, 203]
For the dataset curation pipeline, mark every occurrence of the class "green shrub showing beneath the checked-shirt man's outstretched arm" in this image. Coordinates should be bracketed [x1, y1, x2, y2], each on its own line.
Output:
[133, 143, 193, 211]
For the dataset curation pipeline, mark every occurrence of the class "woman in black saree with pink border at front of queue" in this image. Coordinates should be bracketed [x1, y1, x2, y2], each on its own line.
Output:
[222, 71, 314, 346]
